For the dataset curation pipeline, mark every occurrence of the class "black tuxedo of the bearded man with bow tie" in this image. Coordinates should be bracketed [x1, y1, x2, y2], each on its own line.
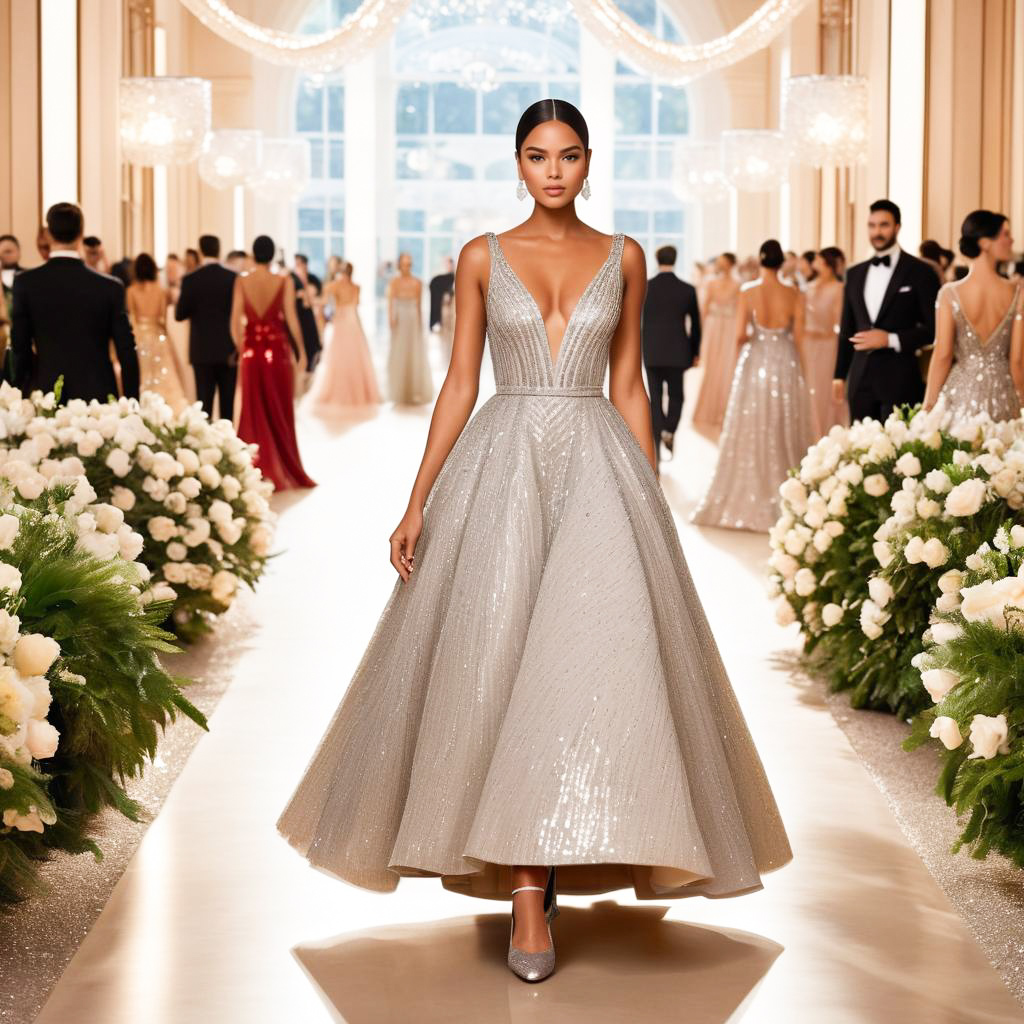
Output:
[836, 251, 939, 406]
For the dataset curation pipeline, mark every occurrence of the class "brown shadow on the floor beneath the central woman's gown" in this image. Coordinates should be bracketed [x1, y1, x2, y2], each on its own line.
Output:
[293, 900, 782, 1024]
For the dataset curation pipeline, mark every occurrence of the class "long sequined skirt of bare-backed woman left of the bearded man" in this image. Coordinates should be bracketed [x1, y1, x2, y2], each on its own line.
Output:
[693, 321, 815, 531]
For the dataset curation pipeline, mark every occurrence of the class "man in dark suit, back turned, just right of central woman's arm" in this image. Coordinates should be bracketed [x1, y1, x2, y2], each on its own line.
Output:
[643, 246, 700, 459]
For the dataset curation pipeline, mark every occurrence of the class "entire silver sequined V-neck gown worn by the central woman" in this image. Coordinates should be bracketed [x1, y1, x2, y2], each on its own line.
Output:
[278, 234, 792, 899]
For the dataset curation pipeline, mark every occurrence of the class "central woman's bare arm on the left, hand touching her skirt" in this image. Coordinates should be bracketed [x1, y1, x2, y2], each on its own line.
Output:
[389, 234, 490, 583]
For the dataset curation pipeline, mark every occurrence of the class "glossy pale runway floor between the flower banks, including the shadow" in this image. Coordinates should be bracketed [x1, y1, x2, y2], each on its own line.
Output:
[39, 376, 1024, 1024]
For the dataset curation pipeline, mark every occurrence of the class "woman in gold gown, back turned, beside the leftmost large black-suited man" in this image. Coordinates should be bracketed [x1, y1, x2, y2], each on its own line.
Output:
[125, 253, 188, 413]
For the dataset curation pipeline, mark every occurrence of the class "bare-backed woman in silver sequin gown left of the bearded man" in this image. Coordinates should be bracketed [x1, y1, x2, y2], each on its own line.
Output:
[693, 239, 815, 530]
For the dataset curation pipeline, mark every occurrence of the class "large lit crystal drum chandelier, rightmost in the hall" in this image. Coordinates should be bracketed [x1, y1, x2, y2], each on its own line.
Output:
[782, 75, 869, 167]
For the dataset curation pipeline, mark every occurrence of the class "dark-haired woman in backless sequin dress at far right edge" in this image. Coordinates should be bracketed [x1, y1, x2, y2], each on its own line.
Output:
[925, 210, 1024, 420]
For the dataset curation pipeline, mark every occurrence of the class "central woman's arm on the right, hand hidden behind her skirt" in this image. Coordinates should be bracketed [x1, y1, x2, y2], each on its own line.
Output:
[606, 238, 657, 473]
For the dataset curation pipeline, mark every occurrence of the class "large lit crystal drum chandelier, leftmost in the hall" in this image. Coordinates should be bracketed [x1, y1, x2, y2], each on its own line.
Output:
[119, 77, 211, 167]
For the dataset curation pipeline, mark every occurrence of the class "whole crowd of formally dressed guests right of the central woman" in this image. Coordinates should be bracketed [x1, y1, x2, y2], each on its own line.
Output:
[644, 200, 1024, 529]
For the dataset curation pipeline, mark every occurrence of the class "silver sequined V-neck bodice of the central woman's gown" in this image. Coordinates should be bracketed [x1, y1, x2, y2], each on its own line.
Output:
[486, 231, 625, 395]
